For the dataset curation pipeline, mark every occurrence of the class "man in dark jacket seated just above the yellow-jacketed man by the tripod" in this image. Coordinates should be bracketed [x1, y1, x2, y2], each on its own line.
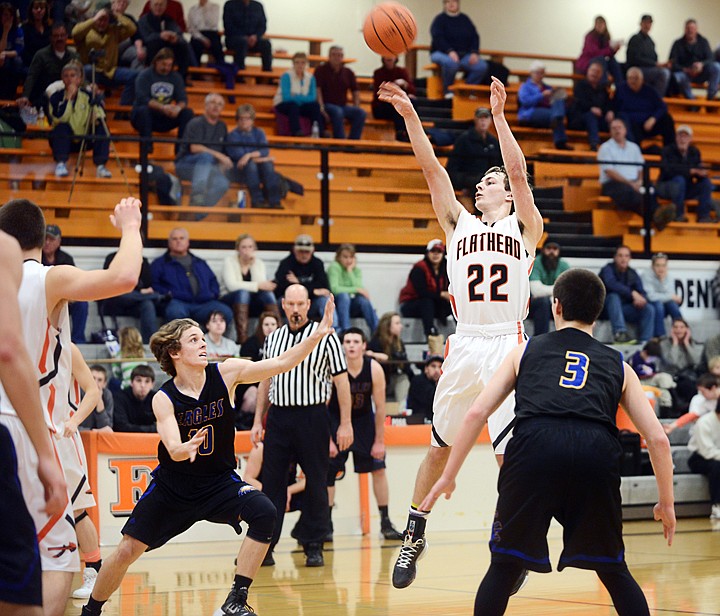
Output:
[17, 23, 80, 108]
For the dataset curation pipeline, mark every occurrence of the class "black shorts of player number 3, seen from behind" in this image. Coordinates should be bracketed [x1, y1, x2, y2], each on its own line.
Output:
[490, 418, 625, 573]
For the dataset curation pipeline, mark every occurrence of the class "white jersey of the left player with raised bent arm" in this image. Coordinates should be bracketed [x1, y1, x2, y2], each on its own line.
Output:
[0, 260, 72, 434]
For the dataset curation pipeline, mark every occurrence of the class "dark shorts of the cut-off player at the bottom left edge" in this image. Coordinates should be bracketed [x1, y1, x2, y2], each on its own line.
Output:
[0, 424, 42, 606]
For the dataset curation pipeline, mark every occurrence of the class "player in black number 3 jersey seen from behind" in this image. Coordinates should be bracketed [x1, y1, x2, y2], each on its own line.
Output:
[421, 269, 675, 616]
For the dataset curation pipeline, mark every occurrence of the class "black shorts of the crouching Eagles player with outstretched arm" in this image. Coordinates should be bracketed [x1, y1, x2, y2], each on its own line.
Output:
[121, 466, 269, 550]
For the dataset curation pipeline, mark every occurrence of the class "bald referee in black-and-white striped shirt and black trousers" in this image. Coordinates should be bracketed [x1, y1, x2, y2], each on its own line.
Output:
[251, 284, 353, 567]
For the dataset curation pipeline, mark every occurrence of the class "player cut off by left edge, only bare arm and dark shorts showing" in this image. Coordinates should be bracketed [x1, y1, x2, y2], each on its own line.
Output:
[0, 232, 67, 616]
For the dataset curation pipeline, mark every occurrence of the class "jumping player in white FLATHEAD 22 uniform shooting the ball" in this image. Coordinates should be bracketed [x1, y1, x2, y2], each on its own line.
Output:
[378, 78, 543, 588]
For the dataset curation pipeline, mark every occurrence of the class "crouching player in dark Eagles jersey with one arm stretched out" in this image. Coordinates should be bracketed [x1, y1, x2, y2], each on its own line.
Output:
[82, 297, 334, 616]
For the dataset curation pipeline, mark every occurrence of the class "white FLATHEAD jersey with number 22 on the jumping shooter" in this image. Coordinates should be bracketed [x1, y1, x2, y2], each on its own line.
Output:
[447, 209, 533, 325]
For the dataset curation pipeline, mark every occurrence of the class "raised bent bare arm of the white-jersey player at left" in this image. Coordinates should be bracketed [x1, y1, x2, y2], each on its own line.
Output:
[45, 197, 142, 314]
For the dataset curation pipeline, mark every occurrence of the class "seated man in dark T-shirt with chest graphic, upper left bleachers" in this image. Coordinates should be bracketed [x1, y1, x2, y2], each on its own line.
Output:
[130, 47, 194, 152]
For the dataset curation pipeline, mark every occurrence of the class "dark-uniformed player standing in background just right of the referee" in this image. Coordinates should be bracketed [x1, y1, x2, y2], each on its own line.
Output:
[328, 327, 402, 541]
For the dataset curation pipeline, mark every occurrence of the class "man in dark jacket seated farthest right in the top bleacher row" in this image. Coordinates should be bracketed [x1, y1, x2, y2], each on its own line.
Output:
[670, 19, 720, 101]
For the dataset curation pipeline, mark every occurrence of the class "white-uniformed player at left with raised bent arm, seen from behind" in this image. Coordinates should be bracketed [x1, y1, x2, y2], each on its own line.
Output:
[0, 198, 142, 616]
